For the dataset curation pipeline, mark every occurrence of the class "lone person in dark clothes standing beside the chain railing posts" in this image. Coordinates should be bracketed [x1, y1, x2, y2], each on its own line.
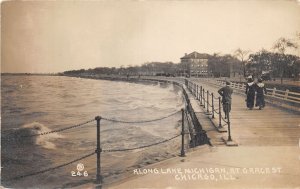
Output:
[218, 81, 233, 119]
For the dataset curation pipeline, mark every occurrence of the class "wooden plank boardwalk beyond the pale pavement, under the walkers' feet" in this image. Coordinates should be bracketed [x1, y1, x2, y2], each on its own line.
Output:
[192, 79, 300, 146]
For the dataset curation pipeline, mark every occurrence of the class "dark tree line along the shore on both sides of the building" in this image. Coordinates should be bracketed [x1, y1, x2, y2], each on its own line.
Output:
[63, 33, 300, 81]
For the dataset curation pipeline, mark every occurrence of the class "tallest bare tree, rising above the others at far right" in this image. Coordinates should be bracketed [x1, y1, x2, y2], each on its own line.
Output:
[273, 37, 298, 84]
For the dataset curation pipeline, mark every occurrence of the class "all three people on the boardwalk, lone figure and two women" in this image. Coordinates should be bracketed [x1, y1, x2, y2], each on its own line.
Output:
[218, 76, 267, 119]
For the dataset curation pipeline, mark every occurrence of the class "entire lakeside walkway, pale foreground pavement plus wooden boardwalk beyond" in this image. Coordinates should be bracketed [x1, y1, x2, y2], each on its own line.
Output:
[107, 78, 300, 189]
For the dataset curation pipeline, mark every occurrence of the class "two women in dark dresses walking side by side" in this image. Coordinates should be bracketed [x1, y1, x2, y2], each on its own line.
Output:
[245, 76, 267, 110]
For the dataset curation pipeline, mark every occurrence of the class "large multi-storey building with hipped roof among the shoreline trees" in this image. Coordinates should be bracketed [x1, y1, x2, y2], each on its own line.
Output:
[180, 52, 210, 77]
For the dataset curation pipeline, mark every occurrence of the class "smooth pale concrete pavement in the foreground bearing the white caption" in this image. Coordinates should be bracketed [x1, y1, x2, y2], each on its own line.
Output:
[107, 146, 300, 189]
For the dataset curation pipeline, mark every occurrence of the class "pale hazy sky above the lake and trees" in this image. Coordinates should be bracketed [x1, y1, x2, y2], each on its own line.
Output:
[1, 0, 300, 73]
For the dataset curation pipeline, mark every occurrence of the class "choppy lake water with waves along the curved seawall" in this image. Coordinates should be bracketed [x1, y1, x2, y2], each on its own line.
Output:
[1, 76, 183, 188]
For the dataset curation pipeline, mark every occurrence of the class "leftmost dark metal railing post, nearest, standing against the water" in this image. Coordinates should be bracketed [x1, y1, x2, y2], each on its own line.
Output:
[95, 116, 102, 189]
